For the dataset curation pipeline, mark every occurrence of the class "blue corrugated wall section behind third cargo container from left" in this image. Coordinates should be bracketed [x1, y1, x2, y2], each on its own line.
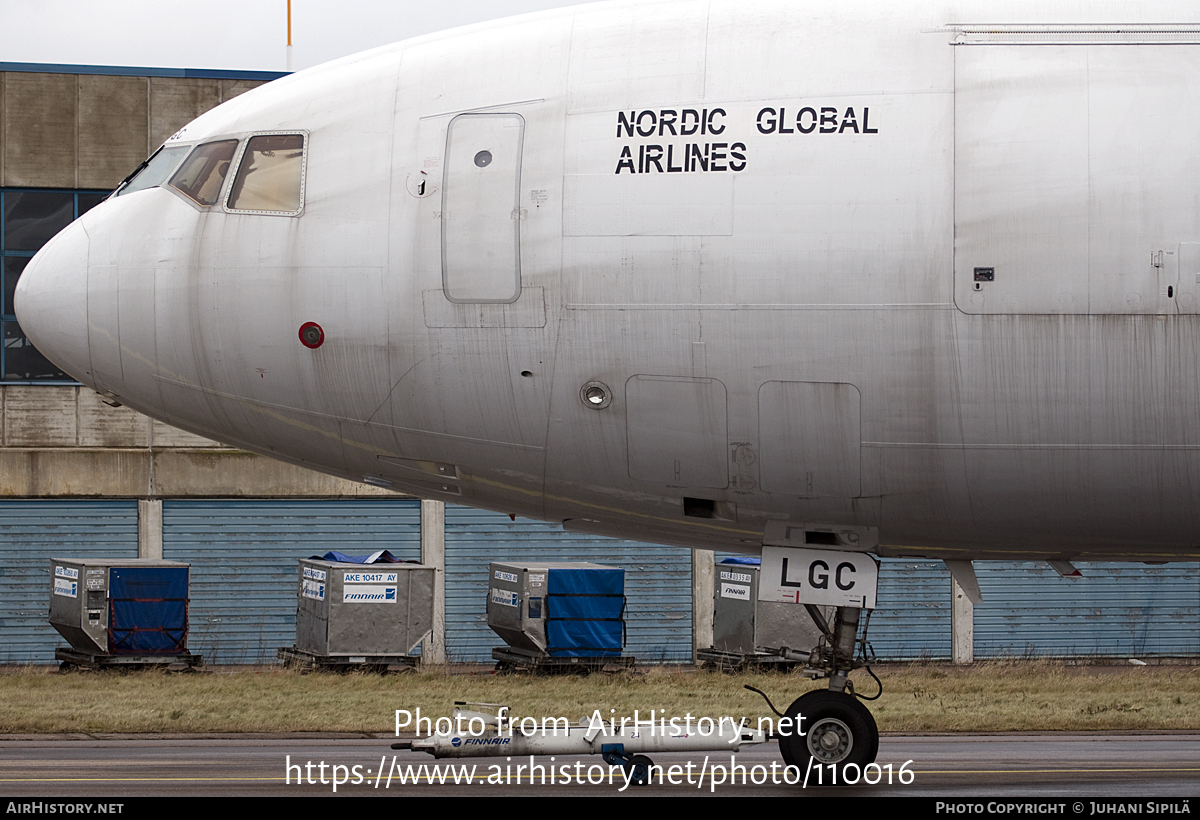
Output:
[445, 504, 691, 663]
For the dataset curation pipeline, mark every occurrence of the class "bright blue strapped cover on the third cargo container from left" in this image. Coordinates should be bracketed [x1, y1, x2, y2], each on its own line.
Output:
[546, 567, 625, 658]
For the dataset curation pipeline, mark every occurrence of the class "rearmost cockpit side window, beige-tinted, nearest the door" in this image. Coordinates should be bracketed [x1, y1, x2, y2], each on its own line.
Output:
[227, 133, 304, 214]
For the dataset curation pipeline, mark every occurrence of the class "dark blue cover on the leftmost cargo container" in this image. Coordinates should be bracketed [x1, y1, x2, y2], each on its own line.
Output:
[108, 567, 187, 654]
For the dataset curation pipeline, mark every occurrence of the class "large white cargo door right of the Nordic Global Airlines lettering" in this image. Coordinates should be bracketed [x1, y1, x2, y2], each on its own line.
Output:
[954, 40, 1200, 315]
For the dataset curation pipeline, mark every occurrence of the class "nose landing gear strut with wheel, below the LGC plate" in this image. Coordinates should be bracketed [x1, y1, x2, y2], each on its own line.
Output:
[779, 604, 880, 771]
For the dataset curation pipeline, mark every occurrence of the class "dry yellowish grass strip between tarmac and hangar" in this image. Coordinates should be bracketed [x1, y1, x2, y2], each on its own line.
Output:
[0, 662, 1200, 735]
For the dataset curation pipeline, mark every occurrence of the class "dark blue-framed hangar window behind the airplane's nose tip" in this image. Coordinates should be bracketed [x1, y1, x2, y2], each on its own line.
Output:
[0, 188, 108, 383]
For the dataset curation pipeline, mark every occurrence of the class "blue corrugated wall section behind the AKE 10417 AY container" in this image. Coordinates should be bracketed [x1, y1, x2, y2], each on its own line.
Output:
[162, 498, 421, 664]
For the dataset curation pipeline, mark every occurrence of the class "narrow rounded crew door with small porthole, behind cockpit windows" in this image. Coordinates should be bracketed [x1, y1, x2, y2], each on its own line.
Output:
[442, 113, 524, 304]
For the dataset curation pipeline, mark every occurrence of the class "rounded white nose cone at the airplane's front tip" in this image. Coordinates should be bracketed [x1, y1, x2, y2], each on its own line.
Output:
[13, 221, 91, 383]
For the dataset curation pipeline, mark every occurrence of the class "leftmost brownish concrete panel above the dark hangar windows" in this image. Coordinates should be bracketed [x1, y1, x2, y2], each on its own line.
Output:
[0, 72, 76, 188]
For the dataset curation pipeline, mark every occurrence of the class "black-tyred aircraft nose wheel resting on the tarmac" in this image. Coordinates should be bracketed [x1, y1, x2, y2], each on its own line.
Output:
[779, 689, 880, 783]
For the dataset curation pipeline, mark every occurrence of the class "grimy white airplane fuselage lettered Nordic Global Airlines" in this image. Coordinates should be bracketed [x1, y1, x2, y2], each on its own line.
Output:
[17, 0, 1200, 561]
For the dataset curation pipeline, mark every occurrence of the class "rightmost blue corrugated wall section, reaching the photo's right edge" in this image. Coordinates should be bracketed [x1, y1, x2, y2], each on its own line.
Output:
[974, 561, 1200, 658]
